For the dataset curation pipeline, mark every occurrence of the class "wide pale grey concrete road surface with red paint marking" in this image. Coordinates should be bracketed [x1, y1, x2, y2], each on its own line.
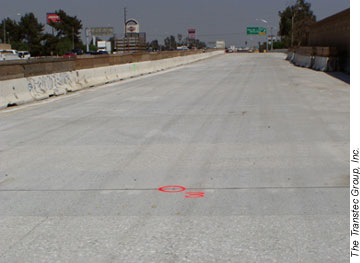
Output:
[0, 54, 349, 263]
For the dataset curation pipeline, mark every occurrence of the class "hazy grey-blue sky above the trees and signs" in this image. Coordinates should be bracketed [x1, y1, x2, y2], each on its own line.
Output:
[0, 0, 350, 46]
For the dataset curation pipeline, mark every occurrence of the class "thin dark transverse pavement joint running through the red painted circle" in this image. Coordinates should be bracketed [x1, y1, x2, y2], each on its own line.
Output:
[0, 185, 349, 192]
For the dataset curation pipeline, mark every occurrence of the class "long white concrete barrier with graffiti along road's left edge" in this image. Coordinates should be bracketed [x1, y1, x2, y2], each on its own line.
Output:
[0, 50, 224, 108]
